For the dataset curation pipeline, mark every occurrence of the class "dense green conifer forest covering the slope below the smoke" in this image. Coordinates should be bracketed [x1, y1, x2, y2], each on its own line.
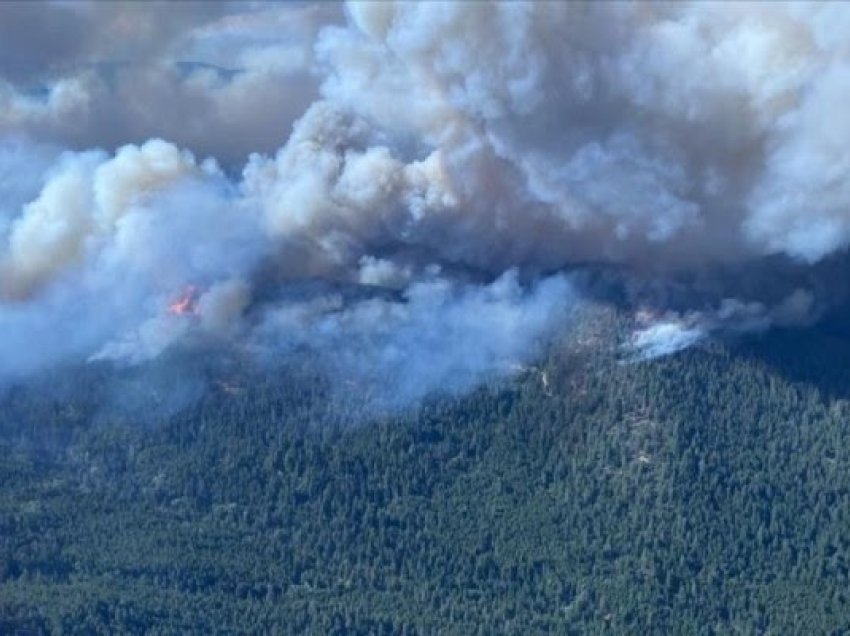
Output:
[0, 316, 850, 635]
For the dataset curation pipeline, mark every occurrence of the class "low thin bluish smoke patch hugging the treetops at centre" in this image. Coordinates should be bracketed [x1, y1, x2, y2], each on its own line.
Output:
[254, 271, 576, 407]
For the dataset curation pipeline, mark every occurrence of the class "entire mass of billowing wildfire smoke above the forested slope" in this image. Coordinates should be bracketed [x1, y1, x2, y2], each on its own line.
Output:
[0, 2, 850, 404]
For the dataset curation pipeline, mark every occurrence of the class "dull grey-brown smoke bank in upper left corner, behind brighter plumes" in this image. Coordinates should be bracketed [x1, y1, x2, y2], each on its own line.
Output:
[0, 1, 342, 166]
